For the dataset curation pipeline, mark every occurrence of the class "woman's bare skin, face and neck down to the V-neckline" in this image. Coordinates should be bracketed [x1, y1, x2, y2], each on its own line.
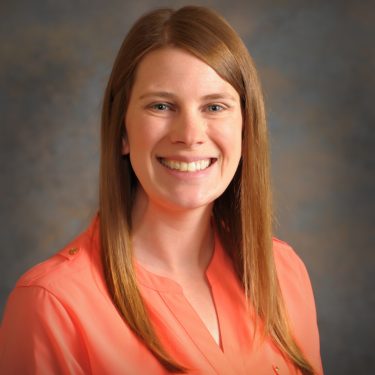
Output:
[123, 47, 242, 344]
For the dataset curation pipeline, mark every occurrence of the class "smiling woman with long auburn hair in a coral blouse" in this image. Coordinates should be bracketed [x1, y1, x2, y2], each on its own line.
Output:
[0, 7, 322, 374]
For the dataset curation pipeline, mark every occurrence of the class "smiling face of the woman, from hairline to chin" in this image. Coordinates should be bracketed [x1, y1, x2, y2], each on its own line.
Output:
[123, 47, 242, 210]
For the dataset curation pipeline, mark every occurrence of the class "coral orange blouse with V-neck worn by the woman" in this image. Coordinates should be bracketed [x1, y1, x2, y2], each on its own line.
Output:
[0, 220, 323, 375]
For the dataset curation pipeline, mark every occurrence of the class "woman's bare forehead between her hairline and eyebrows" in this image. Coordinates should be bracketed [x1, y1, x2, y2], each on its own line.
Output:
[133, 47, 238, 96]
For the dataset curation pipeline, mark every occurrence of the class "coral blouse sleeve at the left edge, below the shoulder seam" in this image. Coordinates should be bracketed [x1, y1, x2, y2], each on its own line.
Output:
[0, 286, 91, 375]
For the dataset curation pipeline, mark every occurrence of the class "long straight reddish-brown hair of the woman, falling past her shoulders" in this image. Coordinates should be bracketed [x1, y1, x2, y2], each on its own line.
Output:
[100, 6, 314, 375]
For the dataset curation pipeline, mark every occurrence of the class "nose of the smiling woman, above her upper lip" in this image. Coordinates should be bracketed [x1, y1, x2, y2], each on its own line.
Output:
[170, 111, 207, 146]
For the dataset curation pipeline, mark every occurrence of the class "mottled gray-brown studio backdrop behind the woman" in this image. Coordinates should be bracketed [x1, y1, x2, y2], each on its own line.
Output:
[0, 0, 375, 375]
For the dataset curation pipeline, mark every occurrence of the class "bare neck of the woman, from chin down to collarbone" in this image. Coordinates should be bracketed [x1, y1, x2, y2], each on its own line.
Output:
[132, 190, 214, 278]
